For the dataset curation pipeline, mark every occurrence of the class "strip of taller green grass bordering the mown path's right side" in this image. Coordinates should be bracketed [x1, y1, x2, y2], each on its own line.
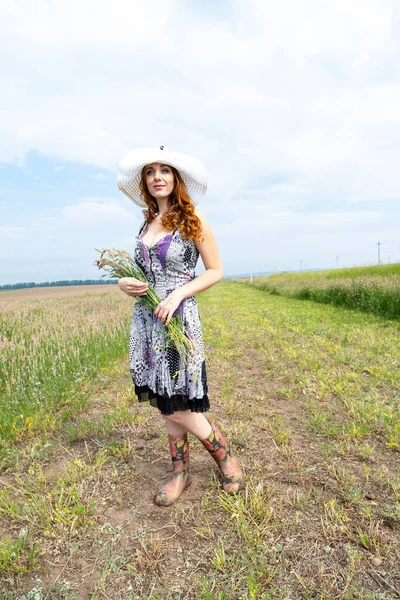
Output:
[244, 263, 400, 320]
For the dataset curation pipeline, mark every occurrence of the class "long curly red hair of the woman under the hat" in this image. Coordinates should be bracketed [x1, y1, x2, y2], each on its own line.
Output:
[140, 165, 204, 241]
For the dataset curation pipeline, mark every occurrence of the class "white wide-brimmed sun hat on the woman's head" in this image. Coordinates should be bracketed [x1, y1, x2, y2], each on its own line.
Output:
[117, 146, 207, 208]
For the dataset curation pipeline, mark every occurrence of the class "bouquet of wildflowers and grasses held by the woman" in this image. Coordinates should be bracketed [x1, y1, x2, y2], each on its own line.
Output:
[93, 248, 196, 363]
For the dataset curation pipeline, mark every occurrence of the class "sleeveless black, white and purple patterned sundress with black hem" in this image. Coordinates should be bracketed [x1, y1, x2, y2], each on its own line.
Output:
[129, 223, 210, 415]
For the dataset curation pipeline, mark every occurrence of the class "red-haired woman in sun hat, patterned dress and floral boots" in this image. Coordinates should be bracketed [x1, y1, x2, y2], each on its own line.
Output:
[118, 146, 243, 506]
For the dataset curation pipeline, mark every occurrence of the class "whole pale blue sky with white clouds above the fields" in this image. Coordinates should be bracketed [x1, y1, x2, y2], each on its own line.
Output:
[0, 0, 400, 284]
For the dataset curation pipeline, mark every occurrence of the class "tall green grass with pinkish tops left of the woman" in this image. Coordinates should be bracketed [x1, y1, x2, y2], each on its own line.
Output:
[0, 291, 132, 452]
